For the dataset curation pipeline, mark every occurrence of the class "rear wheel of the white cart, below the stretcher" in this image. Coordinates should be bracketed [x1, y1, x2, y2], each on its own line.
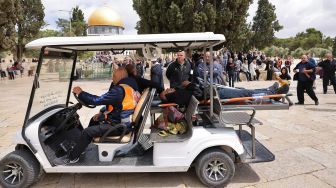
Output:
[195, 149, 235, 187]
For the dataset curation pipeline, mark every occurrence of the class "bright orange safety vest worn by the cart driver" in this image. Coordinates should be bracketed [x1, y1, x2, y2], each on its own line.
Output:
[107, 84, 140, 112]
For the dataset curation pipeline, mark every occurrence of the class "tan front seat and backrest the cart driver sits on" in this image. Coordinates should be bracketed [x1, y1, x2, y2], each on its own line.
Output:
[93, 88, 150, 143]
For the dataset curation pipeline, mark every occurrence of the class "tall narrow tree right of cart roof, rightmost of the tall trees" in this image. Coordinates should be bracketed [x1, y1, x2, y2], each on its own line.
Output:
[251, 0, 283, 48]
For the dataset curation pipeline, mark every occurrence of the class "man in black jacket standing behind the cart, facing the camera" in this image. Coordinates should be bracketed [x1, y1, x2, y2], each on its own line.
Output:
[166, 51, 191, 88]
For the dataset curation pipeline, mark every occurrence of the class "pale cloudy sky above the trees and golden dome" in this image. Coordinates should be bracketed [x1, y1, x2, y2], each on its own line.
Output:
[42, 0, 336, 38]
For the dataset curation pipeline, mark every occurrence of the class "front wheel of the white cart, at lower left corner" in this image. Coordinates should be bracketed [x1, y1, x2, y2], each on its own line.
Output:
[0, 150, 39, 188]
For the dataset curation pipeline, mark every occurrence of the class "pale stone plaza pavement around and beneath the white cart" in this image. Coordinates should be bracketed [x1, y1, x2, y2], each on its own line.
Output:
[0, 75, 336, 188]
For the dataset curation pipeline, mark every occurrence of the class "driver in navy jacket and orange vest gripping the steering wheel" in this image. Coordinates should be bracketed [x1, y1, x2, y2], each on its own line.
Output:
[54, 68, 139, 165]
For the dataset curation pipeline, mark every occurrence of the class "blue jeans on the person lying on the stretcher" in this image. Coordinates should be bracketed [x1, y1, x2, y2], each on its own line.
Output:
[218, 87, 275, 99]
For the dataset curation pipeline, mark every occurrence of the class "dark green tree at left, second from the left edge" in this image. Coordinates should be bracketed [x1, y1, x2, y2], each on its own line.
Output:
[16, 0, 45, 60]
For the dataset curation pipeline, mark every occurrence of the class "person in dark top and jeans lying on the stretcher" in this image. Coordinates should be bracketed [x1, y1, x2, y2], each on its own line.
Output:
[160, 78, 289, 106]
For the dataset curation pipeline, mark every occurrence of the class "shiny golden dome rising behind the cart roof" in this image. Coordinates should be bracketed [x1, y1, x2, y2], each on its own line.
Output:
[88, 7, 124, 28]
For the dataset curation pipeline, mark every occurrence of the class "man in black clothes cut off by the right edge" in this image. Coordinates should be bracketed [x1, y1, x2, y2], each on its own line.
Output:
[318, 53, 336, 94]
